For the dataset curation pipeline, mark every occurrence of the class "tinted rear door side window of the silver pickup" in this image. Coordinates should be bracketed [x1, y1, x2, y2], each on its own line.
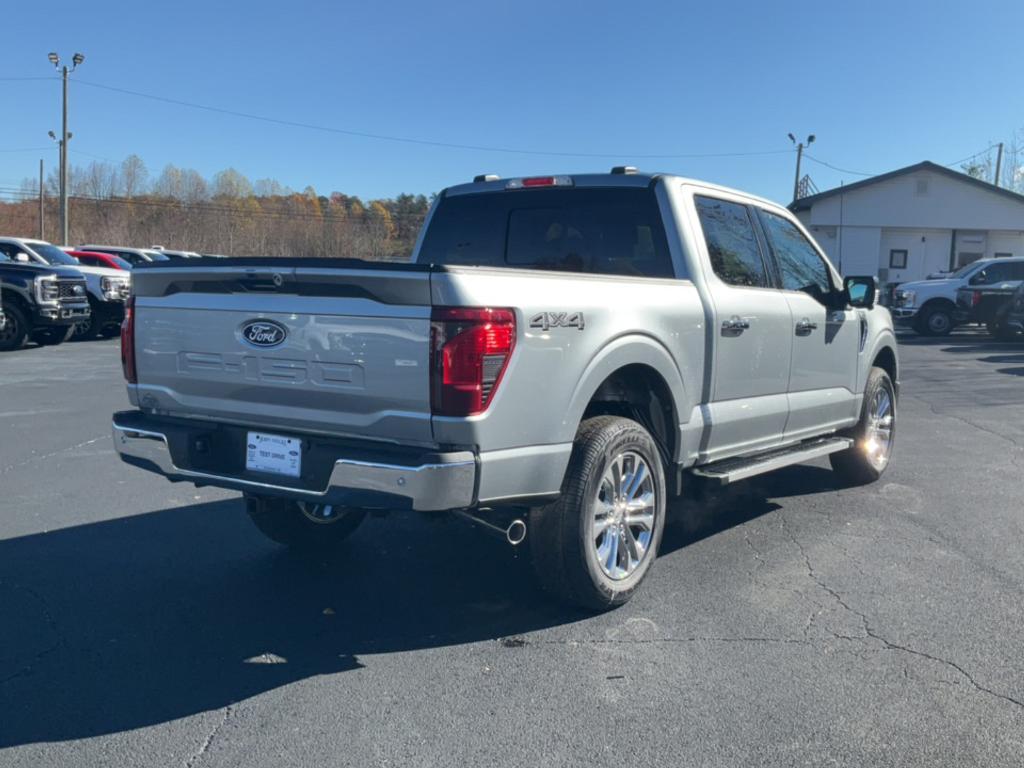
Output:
[694, 196, 768, 288]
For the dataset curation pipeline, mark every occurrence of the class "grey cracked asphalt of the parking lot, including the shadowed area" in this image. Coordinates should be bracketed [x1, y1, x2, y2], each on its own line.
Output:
[0, 332, 1024, 768]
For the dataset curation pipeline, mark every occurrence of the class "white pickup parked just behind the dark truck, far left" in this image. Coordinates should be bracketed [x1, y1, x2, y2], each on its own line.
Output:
[0, 238, 131, 339]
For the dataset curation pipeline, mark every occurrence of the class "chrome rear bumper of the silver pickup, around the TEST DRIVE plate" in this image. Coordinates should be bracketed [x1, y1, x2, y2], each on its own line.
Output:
[113, 419, 476, 512]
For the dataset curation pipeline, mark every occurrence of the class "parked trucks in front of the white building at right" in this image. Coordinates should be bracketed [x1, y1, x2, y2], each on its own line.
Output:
[890, 257, 1024, 340]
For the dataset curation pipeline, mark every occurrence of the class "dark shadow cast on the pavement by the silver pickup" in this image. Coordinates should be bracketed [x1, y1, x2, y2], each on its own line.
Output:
[0, 467, 834, 748]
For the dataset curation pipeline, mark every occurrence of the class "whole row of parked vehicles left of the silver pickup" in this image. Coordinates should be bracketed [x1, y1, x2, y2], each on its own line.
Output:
[0, 236, 218, 351]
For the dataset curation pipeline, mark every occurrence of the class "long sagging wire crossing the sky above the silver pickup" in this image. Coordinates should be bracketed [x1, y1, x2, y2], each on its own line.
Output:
[75, 80, 790, 160]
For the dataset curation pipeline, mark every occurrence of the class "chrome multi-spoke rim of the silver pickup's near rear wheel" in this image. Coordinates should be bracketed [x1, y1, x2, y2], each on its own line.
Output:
[589, 451, 658, 581]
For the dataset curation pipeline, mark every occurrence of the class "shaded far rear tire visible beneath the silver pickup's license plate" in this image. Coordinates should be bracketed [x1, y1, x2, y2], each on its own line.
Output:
[246, 496, 367, 552]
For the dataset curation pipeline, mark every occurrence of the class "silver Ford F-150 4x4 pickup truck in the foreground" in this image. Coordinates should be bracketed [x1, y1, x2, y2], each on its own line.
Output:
[114, 168, 898, 609]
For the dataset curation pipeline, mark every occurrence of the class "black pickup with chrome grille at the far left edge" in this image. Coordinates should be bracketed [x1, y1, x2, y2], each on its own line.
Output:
[0, 249, 89, 351]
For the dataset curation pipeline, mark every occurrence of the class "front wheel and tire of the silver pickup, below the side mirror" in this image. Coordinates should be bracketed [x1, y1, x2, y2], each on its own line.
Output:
[828, 368, 896, 485]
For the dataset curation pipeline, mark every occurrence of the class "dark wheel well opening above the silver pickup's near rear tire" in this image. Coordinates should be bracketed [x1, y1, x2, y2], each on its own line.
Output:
[583, 364, 679, 469]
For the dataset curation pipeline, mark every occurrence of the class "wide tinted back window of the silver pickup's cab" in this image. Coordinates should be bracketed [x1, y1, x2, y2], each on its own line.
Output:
[418, 187, 674, 278]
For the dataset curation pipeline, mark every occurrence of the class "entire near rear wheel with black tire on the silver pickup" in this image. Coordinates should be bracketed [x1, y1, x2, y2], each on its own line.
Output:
[528, 416, 666, 610]
